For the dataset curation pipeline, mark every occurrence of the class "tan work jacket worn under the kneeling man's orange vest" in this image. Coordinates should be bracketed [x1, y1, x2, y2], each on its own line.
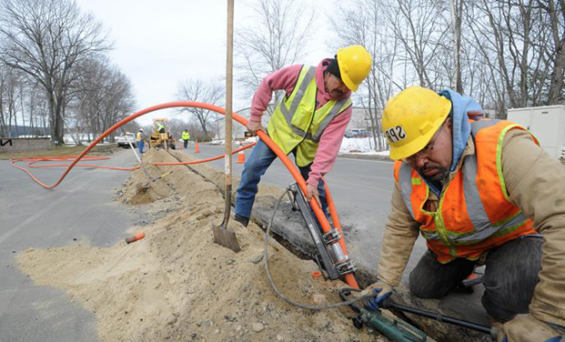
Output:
[377, 130, 565, 326]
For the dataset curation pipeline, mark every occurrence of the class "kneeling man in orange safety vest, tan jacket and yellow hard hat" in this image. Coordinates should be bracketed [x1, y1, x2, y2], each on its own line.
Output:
[363, 87, 565, 342]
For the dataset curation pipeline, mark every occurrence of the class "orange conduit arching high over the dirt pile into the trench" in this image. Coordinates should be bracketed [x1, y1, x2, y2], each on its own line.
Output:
[13, 101, 359, 289]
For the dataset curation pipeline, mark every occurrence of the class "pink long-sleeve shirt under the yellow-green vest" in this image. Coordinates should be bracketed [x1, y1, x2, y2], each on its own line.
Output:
[250, 59, 352, 187]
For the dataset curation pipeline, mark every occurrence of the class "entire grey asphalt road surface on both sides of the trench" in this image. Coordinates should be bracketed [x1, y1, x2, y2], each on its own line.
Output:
[0, 144, 424, 342]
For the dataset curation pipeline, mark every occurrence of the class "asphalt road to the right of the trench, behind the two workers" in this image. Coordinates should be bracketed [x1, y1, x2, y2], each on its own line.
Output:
[178, 144, 426, 276]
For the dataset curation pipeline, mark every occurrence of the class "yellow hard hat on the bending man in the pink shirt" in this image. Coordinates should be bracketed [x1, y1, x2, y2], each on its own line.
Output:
[337, 45, 372, 91]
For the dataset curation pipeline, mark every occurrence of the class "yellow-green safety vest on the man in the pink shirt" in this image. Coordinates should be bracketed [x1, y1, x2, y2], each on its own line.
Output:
[267, 66, 351, 167]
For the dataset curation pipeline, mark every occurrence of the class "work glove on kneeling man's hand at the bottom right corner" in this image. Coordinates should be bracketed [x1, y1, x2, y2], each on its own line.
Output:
[494, 314, 565, 342]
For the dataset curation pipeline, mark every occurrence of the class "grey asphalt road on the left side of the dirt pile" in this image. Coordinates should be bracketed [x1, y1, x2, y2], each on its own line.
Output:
[0, 151, 135, 342]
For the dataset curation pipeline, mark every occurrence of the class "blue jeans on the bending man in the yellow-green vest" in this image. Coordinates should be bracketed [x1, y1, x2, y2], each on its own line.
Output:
[234, 140, 328, 218]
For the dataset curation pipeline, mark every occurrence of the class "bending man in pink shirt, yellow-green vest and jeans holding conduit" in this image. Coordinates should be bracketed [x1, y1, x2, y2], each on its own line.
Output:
[231, 45, 371, 226]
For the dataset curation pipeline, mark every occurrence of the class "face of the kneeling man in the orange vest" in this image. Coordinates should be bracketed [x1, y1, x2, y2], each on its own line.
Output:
[406, 118, 453, 181]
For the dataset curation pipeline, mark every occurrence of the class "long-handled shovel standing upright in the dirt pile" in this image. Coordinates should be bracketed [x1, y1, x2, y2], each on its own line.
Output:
[212, 0, 241, 253]
